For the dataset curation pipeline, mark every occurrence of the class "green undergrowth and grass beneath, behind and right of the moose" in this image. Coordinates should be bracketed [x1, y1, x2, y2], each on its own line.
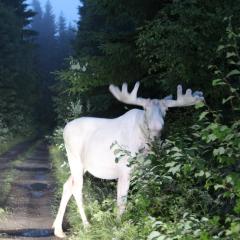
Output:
[51, 21, 240, 240]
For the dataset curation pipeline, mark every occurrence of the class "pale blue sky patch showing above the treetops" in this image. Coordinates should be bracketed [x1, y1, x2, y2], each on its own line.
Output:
[27, 0, 79, 23]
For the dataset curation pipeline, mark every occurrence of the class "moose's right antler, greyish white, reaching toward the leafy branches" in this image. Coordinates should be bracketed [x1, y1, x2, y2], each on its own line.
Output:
[164, 85, 204, 107]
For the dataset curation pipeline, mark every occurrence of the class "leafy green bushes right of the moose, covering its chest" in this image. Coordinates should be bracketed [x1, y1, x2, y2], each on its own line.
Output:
[124, 24, 240, 239]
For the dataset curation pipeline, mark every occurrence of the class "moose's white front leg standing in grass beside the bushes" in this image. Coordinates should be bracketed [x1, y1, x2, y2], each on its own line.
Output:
[117, 171, 130, 218]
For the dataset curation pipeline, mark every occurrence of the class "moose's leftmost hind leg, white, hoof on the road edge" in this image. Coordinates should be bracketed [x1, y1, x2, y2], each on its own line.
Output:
[53, 176, 73, 238]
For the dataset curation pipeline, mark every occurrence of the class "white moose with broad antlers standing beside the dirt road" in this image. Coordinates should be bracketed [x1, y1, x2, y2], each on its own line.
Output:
[53, 82, 204, 238]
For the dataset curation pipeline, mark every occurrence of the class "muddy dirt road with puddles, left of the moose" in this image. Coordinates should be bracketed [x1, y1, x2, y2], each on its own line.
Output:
[0, 141, 55, 240]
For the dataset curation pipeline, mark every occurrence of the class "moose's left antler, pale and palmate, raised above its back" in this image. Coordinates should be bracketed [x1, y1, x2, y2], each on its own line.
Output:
[109, 82, 146, 107]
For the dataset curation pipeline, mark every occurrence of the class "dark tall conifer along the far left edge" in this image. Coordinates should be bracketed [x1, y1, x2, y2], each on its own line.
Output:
[0, 0, 37, 129]
